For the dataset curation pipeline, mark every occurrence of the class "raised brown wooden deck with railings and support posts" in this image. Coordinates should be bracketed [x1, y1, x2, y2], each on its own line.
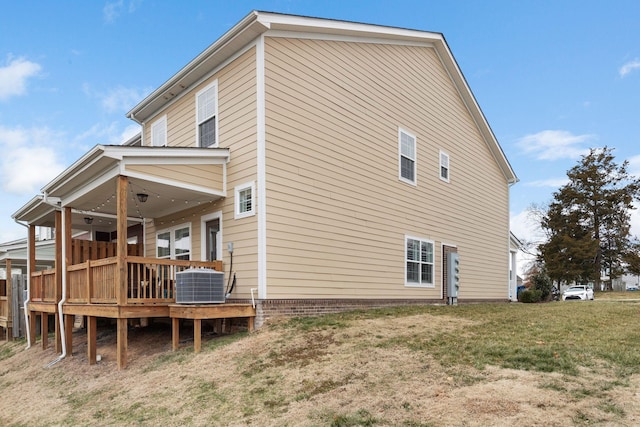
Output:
[29, 249, 255, 369]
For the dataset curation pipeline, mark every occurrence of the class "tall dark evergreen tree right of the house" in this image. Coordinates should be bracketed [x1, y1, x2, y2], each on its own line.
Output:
[539, 147, 640, 289]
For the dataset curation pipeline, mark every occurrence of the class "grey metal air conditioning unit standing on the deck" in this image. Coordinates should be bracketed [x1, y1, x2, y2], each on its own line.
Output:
[176, 268, 225, 304]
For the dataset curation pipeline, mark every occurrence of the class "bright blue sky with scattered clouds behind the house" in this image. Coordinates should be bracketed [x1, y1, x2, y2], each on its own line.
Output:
[0, 0, 640, 270]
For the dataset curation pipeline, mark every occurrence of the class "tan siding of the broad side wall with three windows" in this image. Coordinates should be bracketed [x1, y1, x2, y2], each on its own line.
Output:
[265, 38, 508, 298]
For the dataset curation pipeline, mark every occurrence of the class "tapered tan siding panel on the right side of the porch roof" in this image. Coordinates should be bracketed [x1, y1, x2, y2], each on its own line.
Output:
[127, 164, 224, 191]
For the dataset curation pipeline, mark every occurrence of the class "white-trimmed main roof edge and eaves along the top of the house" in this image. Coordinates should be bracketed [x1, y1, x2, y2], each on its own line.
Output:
[127, 11, 518, 184]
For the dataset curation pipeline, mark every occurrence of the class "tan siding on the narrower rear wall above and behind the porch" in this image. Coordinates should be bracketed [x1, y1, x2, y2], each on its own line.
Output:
[141, 48, 258, 298]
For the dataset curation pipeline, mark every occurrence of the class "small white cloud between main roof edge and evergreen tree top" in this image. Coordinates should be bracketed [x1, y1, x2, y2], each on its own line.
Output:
[517, 130, 595, 160]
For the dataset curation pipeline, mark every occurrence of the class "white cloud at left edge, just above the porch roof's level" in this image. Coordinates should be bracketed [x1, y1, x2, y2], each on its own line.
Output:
[0, 126, 64, 195]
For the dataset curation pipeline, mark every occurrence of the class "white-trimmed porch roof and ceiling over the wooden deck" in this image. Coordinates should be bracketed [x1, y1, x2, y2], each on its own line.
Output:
[13, 145, 229, 230]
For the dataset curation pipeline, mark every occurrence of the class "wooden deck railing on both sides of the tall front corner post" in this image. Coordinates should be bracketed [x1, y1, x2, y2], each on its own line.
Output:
[67, 256, 222, 304]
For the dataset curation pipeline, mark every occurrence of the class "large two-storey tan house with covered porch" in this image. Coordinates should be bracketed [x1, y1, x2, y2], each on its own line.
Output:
[14, 12, 517, 367]
